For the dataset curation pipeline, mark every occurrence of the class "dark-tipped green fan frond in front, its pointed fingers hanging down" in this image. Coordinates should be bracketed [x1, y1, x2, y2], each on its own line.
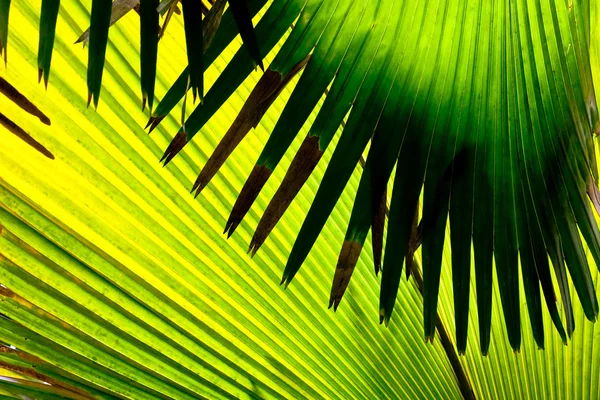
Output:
[0, 0, 600, 360]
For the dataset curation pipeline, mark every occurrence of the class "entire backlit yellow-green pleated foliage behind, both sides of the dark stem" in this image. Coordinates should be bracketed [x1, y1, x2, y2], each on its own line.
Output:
[0, 0, 600, 399]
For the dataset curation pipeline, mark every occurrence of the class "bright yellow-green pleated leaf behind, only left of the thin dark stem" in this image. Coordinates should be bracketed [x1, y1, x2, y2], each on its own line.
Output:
[0, 3, 468, 398]
